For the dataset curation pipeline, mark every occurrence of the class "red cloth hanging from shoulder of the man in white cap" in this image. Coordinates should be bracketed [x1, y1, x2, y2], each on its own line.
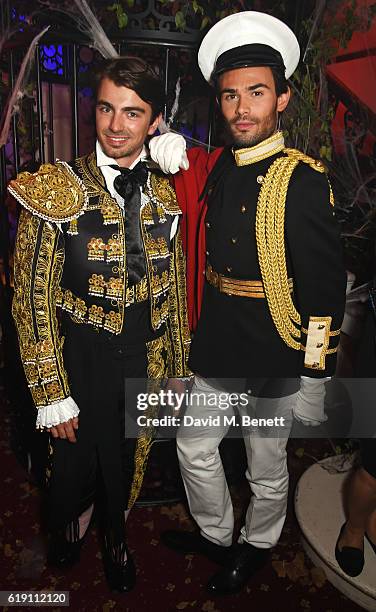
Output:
[174, 147, 223, 331]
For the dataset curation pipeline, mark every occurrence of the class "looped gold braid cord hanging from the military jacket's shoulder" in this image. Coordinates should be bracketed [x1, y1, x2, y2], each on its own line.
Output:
[256, 149, 325, 350]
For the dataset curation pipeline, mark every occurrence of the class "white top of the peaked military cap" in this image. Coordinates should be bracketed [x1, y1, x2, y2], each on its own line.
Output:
[198, 11, 300, 81]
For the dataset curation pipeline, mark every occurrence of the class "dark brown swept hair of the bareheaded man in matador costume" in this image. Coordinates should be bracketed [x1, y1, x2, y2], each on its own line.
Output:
[94, 55, 164, 121]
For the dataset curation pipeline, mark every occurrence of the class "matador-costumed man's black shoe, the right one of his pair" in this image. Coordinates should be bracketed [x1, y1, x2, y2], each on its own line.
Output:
[103, 542, 136, 593]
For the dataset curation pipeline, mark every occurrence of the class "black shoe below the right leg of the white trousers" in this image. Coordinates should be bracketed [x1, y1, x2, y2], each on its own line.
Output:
[206, 543, 269, 595]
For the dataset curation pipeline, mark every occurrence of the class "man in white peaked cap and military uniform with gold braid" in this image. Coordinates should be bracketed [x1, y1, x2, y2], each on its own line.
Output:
[151, 11, 346, 594]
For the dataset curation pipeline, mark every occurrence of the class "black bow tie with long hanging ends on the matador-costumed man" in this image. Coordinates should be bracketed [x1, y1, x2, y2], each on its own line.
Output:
[111, 161, 148, 287]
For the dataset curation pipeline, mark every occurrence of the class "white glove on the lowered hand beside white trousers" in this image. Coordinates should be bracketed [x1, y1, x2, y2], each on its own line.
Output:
[292, 376, 330, 427]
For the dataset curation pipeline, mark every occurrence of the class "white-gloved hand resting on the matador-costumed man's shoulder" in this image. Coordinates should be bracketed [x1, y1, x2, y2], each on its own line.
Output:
[149, 132, 189, 174]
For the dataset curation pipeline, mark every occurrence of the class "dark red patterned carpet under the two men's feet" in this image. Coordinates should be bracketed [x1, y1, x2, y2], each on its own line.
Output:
[0, 388, 360, 612]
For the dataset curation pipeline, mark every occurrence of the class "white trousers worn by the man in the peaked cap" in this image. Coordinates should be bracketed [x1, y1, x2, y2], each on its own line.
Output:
[177, 376, 296, 548]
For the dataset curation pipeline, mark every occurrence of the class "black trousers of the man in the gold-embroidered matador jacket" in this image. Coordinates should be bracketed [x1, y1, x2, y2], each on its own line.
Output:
[49, 322, 151, 542]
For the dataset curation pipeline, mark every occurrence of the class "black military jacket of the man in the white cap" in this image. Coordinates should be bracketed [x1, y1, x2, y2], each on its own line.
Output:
[189, 149, 346, 392]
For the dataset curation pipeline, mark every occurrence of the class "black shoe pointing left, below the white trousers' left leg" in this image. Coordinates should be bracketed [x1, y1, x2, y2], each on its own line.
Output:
[161, 530, 232, 565]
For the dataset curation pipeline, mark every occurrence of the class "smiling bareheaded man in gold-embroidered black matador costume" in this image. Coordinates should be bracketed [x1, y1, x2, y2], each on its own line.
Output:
[9, 56, 190, 591]
